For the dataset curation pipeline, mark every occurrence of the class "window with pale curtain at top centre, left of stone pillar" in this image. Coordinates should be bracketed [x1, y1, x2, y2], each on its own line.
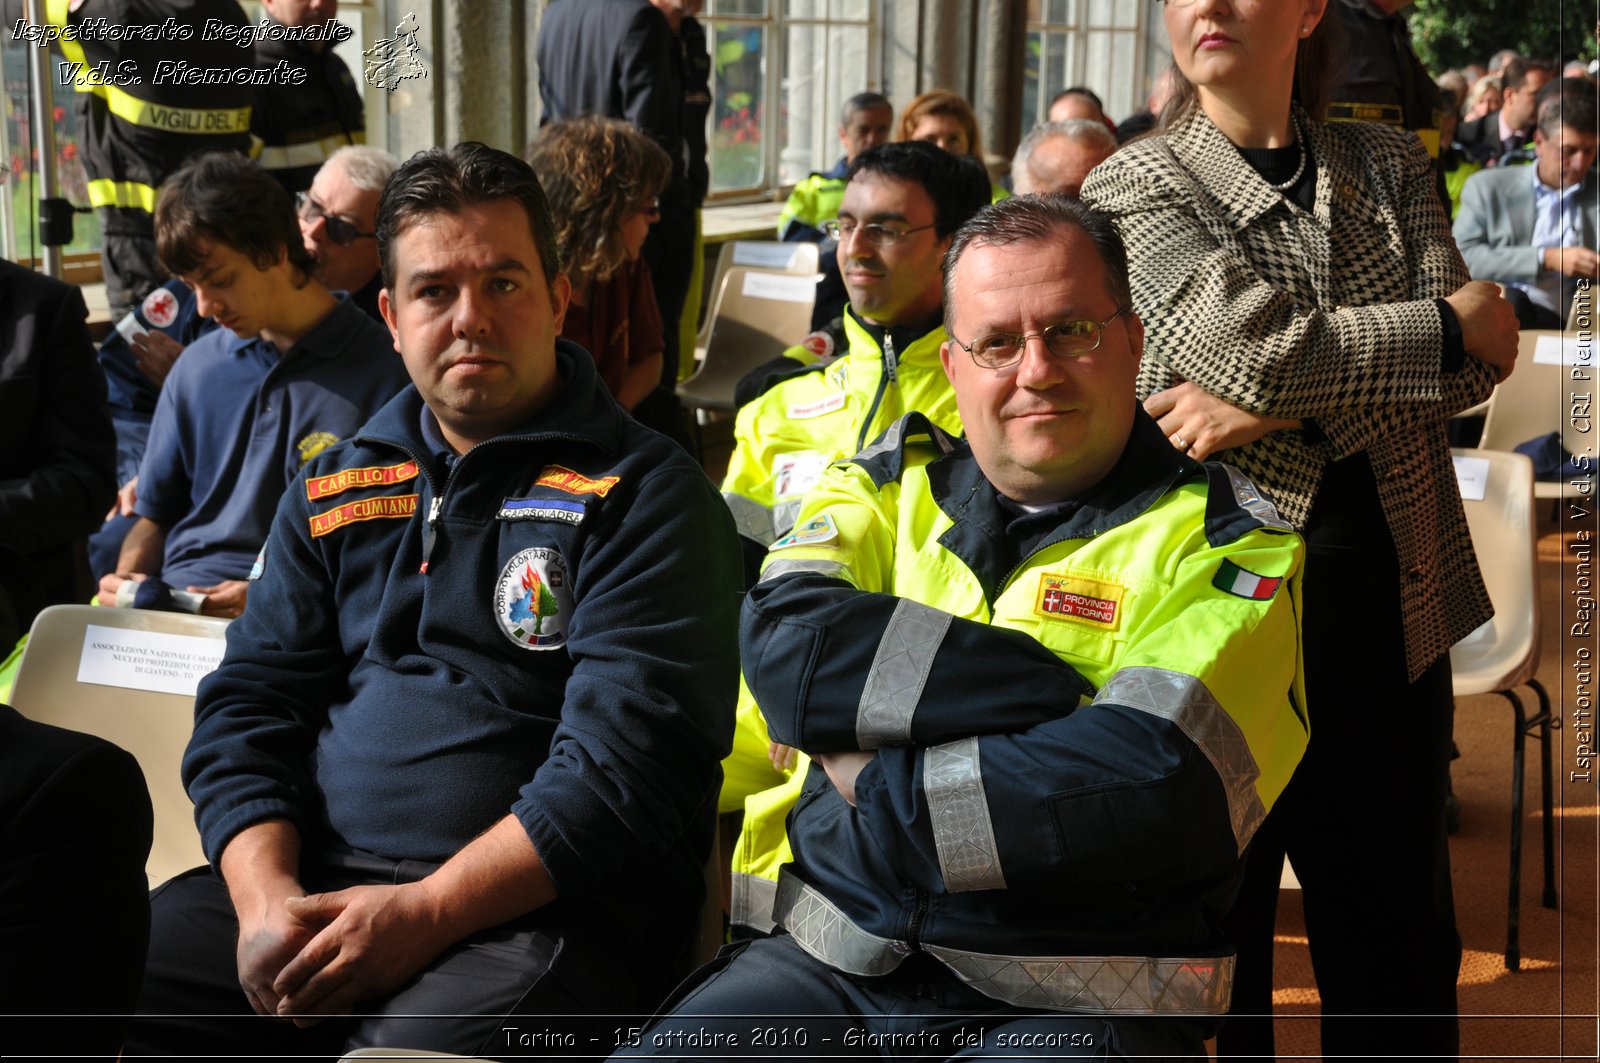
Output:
[704, 0, 880, 195]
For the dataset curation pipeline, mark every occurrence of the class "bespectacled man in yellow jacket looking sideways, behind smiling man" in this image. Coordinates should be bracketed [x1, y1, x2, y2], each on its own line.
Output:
[720, 142, 989, 930]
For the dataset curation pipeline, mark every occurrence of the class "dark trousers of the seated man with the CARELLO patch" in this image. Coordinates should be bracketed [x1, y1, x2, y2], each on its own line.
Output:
[125, 868, 662, 1060]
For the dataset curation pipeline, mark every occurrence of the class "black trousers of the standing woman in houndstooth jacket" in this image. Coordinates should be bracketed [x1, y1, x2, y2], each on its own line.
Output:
[1218, 503, 1461, 1058]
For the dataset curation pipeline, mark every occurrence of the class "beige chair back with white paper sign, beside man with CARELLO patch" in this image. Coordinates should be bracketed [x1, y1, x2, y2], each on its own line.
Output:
[11, 605, 227, 885]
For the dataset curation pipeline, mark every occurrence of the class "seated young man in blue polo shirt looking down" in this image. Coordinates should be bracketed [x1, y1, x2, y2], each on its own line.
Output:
[99, 152, 406, 616]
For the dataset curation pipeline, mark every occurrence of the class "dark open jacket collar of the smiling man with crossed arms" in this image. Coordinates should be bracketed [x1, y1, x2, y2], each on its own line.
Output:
[928, 408, 1205, 605]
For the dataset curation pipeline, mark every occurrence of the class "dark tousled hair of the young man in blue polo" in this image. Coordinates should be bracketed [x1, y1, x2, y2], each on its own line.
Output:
[155, 152, 317, 283]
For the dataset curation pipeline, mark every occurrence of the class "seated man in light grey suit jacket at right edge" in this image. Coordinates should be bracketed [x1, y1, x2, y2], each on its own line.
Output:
[1454, 80, 1600, 328]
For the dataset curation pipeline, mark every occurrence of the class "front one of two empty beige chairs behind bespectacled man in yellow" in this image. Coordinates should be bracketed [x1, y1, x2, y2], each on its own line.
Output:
[678, 266, 816, 410]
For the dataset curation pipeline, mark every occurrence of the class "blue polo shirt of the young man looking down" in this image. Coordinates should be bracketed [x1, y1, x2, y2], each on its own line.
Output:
[138, 295, 410, 588]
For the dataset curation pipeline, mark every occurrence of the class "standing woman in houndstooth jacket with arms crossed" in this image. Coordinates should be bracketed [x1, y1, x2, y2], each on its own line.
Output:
[1083, 0, 1517, 1058]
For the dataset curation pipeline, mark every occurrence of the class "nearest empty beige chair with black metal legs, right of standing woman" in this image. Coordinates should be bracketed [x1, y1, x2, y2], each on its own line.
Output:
[1450, 448, 1562, 970]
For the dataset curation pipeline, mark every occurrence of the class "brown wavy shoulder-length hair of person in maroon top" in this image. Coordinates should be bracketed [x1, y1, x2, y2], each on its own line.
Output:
[528, 115, 672, 288]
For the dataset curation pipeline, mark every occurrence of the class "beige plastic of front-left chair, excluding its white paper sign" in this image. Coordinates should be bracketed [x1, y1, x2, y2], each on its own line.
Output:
[11, 605, 227, 887]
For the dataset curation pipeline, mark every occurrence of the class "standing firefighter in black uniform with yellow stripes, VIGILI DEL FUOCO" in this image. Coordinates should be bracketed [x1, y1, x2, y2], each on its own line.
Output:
[34, 0, 254, 320]
